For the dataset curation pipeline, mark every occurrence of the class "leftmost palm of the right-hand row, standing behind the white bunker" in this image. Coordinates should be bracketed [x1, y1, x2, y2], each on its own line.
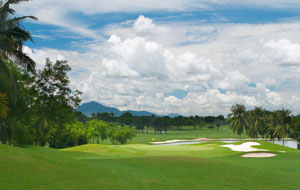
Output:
[228, 104, 247, 140]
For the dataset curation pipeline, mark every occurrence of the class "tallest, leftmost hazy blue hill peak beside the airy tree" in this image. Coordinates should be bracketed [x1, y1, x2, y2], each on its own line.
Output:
[77, 102, 122, 116]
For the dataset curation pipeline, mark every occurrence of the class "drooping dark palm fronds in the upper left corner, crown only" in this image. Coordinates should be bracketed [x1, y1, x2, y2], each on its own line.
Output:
[0, 0, 37, 73]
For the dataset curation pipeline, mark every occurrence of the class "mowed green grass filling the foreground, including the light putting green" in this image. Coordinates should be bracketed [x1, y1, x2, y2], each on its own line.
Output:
[0, 141, 300, 190]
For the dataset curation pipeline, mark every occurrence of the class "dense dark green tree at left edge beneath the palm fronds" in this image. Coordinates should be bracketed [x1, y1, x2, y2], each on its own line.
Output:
[0, 62, 34, 144]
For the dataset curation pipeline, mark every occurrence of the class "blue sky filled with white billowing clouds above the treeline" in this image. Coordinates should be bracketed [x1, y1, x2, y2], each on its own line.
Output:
[14, 0, 300, 116]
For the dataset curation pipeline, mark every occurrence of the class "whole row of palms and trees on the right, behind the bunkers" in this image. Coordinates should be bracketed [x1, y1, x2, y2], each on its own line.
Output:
[228, 104, 300, 149]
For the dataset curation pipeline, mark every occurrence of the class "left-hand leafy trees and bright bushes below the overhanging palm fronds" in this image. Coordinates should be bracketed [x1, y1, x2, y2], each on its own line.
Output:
[0, 56, 135, 148]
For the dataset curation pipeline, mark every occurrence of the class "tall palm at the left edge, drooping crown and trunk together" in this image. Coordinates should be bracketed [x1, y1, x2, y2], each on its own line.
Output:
[0, 0, 37, 144]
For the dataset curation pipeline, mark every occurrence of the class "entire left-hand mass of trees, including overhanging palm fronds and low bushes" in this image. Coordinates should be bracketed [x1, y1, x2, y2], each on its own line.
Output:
[0, 0, 134, 148]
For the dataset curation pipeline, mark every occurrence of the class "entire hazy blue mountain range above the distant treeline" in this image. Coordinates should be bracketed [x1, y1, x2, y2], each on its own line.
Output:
[77, 101, 180, 117]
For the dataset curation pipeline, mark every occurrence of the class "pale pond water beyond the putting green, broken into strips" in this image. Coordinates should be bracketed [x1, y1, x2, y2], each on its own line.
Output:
[159, 140, 297, 149]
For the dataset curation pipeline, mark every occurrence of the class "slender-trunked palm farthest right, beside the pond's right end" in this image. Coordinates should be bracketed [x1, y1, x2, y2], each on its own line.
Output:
[275, 109, 292, 146]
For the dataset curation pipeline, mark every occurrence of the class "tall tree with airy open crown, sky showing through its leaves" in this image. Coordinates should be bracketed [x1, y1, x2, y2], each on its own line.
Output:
[32, 59, 81, 148]
